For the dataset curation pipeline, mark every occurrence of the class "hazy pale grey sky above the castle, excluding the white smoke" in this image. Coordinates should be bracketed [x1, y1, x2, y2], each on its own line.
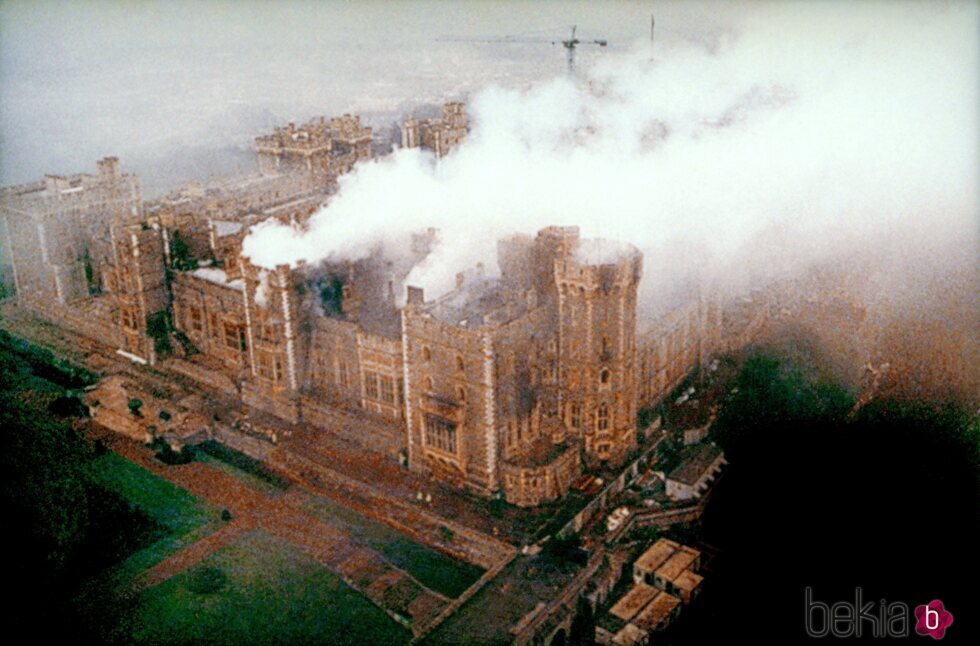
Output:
[0, 0, 736, 195]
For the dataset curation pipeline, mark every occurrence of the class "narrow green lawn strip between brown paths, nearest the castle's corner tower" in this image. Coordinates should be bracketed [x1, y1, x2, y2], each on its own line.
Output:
[302, 494, 484, 598]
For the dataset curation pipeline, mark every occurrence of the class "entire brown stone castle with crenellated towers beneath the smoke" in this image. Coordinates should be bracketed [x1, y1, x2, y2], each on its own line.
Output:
[0, 104, 736, 507]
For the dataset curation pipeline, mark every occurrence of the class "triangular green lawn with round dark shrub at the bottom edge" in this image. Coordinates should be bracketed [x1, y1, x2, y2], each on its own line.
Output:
[119, 531, 411, 645]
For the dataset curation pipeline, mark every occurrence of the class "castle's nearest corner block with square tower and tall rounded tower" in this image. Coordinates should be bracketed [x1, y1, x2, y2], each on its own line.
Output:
[402, 227, 642, 505]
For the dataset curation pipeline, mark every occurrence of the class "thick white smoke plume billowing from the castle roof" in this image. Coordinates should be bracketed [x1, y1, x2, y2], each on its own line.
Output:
[244, 2, 980, 312]
